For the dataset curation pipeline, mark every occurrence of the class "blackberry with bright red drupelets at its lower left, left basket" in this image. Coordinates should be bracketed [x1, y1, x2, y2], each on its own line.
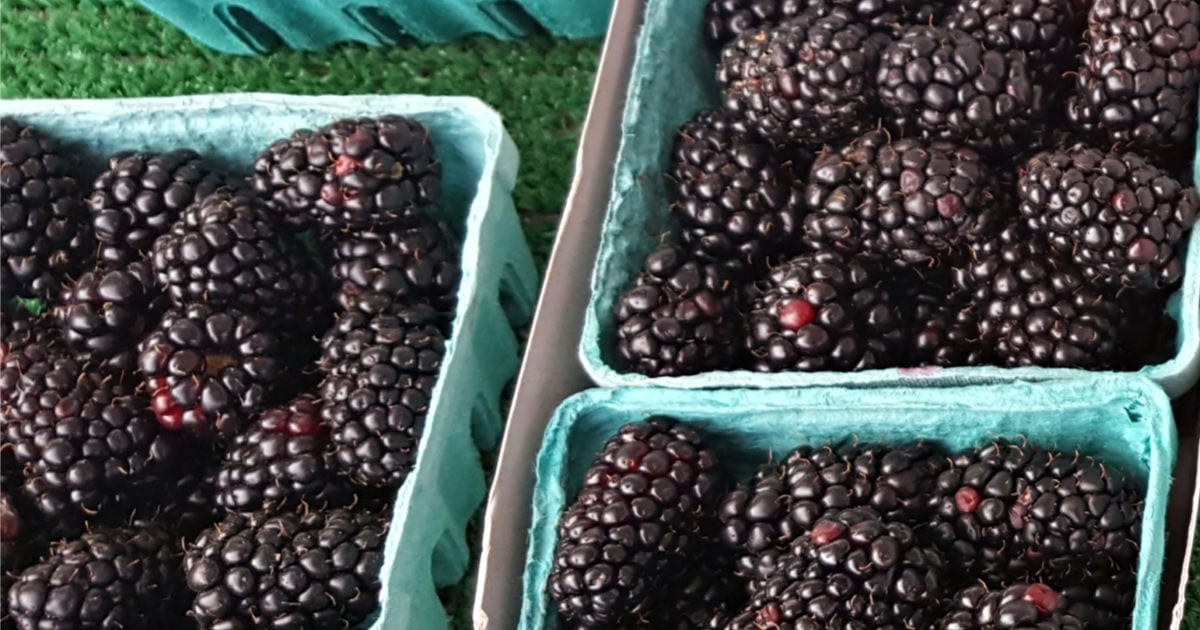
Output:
[138, 304, 280, 436]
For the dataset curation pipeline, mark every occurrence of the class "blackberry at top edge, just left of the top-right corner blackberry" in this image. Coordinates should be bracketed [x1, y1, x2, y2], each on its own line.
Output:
[943, 0, 1081, 77]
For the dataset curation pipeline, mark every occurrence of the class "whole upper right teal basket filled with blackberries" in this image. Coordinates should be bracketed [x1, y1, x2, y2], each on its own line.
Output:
[582, 0, 1200, 395]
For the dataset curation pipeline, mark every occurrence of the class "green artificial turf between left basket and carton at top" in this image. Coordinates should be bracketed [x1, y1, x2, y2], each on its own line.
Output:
[0, 0, 600, 262]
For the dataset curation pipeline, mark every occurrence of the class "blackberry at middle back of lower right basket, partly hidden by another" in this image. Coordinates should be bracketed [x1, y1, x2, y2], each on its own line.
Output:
[719, 443, 946, 578]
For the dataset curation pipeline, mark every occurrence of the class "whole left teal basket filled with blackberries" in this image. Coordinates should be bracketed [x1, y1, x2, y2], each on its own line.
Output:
[0, 95, 535, 630]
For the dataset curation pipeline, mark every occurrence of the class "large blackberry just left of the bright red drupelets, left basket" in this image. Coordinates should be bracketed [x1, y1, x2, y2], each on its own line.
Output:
[5, 380, 190, 536]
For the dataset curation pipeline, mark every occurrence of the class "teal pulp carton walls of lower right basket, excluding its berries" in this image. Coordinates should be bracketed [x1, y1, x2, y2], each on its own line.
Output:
[520, 376, 1176, 630]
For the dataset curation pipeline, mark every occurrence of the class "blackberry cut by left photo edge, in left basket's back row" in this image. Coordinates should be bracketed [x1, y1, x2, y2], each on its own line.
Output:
[0, 118, 90, 300]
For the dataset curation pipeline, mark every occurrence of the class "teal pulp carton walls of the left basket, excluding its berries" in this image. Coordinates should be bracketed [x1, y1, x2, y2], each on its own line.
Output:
[0, 94, 538, 629]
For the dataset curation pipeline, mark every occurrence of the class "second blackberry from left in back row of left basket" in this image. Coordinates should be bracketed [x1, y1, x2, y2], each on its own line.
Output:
[88, 149, 226, 264]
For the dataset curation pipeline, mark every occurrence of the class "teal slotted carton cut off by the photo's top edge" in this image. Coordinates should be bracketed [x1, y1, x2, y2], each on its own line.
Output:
[139, 0, 612, 55]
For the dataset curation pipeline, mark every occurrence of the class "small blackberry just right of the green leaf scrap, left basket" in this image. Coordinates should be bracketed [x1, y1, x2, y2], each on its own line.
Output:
[54, 262, 166, 371]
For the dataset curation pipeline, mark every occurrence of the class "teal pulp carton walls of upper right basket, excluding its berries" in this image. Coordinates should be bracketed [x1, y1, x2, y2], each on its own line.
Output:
[580, 0, 1200, 397]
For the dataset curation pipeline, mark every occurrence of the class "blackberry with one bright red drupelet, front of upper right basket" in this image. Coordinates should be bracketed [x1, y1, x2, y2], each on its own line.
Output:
[746, 250, 902, 372]
